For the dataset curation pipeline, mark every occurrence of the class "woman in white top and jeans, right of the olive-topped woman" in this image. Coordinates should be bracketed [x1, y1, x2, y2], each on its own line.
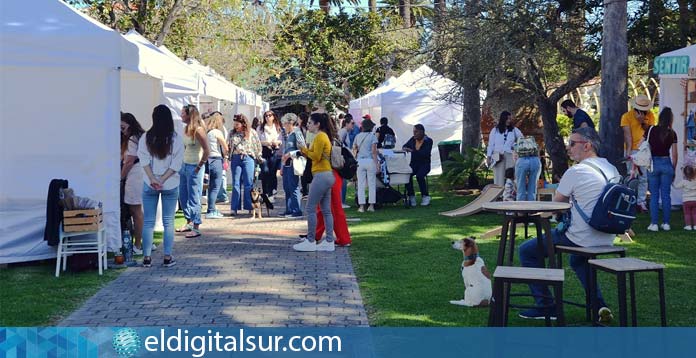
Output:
[205, 112, 228, 219]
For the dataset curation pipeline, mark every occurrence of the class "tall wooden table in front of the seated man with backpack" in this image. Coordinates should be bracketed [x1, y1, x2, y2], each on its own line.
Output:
[483, 201, 570, 268]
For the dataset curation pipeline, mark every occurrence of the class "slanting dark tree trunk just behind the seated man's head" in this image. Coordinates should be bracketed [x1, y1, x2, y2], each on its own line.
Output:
[536, 95, 568, 182]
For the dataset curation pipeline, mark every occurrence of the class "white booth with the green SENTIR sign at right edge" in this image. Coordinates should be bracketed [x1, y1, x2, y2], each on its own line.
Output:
[655, 45, 696, 205]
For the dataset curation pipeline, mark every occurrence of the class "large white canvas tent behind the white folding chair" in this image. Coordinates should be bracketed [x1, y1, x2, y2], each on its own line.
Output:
[0, 0, 147, 263]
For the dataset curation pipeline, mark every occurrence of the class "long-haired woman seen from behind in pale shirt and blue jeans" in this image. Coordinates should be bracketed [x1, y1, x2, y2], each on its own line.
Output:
[138, 104, 184, 267]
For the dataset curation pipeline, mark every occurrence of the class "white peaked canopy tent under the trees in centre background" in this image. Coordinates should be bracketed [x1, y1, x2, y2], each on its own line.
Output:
[348, 65, 462, 175]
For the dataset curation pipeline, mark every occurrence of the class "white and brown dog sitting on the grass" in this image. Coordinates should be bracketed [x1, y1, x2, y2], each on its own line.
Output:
[450, 237, 493, 307]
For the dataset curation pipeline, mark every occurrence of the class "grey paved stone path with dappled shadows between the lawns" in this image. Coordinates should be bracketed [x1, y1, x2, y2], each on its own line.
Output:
[60, 189, 368, 327]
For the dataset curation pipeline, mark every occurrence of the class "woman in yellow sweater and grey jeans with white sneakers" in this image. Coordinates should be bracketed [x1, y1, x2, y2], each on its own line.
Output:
[292, 113, 336, 251]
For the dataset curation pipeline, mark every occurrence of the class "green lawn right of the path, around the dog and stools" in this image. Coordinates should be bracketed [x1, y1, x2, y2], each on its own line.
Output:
[347, 178, 696, 326]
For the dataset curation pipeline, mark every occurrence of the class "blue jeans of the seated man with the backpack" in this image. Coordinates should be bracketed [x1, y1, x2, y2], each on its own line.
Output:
[520, 229, 607, 307]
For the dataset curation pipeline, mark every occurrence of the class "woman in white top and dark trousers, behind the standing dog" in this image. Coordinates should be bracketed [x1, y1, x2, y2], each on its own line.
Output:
[257, 111, 283, 200]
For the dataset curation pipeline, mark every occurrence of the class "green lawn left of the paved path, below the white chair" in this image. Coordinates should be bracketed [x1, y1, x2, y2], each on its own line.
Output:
[0, 213, 185, 327]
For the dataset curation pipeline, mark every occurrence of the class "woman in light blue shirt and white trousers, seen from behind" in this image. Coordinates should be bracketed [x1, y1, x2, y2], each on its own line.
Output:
[353, 118, 379, 213]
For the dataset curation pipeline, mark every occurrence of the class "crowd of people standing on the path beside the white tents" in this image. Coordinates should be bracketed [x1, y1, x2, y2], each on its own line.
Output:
[121, 105, 433, 267]
